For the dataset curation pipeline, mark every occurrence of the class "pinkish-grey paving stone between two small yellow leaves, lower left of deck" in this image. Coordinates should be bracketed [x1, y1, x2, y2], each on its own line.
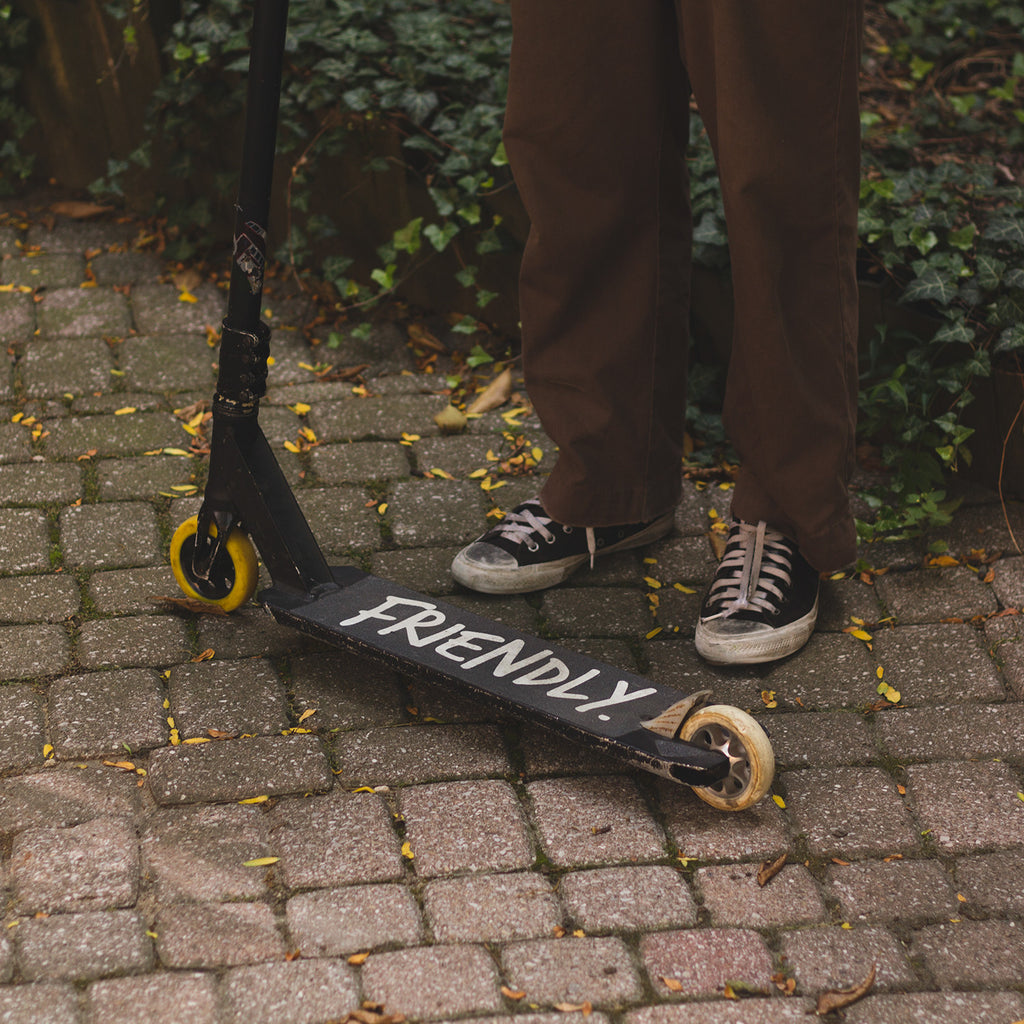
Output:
[270, 791, 404, 889]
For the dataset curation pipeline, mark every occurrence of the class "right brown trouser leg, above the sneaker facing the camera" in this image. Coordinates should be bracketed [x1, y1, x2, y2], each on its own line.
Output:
[677, 0, 862, 569]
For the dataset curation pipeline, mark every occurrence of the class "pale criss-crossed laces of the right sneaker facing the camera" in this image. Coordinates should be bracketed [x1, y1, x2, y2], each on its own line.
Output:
[709, 521, 793, 617]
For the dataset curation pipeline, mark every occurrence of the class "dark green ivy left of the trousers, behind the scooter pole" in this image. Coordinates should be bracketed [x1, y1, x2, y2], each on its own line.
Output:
[96, 0, 511, 307]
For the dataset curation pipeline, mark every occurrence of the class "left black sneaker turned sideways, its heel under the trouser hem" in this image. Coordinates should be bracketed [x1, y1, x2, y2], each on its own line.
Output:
[452, 498, 673, 594]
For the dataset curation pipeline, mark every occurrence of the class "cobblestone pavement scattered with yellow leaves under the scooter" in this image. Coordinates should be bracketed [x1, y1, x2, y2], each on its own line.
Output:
[0, 207, 1024, 1024]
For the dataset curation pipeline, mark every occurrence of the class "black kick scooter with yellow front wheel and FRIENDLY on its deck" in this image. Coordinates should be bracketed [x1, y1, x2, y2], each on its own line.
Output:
[170, 0, 774, 810]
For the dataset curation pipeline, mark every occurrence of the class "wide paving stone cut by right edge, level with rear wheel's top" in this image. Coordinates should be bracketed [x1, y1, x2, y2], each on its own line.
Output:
[874, 703, 1024, 761]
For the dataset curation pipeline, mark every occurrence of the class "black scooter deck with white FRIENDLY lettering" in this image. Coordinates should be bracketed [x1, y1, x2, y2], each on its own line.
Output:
[259, 566, 729, 785]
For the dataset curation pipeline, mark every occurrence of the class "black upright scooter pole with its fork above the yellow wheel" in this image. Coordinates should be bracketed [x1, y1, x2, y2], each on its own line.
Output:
[191, 0, 333, 593]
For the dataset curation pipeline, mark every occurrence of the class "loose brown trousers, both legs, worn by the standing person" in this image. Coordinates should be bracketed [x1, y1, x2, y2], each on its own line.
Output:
[505, 0, 862, 570]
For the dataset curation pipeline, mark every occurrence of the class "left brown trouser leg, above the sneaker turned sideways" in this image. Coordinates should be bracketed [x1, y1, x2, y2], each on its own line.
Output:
[505, 0, 690, 526]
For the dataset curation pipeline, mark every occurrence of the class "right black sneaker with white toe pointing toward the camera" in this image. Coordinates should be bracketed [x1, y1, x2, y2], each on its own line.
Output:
[694, 522, 819, 665]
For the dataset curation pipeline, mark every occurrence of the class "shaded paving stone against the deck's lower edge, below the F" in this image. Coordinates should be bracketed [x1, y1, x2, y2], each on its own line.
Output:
[289, 651, 406, 733]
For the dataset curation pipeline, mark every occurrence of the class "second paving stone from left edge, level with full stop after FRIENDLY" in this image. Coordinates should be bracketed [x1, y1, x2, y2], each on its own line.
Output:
[49, 669, 168, 758]
